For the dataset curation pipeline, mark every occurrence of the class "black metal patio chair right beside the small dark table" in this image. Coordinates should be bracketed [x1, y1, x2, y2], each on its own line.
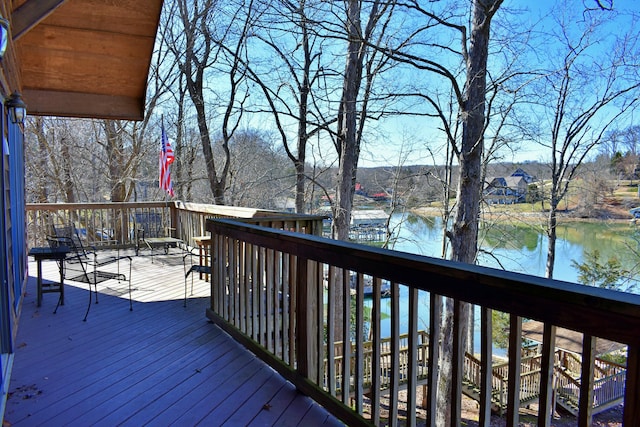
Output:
[47, 225, 133, 321]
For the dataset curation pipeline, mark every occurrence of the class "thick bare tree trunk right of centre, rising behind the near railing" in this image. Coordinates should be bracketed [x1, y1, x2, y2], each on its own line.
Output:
[380, 0, 502, 425]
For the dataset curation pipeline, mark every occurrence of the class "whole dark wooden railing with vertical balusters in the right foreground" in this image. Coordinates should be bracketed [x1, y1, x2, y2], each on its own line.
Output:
[206, 220, 640, 426]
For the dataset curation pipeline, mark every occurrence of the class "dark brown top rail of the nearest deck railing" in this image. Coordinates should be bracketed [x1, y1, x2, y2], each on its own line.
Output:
[206, 219, 640, 345]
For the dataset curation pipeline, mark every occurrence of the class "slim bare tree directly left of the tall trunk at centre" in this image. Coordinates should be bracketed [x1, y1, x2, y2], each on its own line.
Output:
[245, 0, 335, 213]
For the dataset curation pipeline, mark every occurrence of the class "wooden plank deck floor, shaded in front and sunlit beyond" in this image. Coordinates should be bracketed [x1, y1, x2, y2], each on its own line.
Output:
[5, 254, 341, 426]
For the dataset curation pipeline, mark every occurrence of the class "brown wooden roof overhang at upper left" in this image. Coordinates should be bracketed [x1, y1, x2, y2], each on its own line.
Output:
[3, 0, 163, 120]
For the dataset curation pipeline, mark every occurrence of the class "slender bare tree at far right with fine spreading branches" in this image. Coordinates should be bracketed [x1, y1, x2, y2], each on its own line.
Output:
[532, 4, 640, 278]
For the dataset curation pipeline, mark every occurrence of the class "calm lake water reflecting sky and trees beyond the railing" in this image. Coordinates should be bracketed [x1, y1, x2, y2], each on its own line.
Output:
[366, 215, 640, 355]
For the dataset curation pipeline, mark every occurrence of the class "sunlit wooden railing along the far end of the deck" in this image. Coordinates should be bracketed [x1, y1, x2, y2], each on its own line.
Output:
[26, 201, 325, 248]
